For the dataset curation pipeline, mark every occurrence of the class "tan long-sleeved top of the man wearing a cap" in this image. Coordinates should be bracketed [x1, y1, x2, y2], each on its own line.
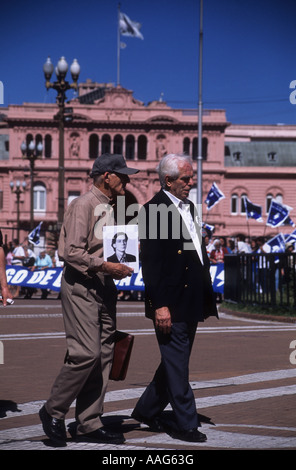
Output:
[58, 186, 114, 277]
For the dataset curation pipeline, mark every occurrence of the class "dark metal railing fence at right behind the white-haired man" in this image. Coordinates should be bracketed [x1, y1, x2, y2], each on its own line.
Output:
[224, 253, 296, 313]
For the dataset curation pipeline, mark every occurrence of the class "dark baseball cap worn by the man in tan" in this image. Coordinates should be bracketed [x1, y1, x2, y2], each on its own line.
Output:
[90, 153, 139, 178]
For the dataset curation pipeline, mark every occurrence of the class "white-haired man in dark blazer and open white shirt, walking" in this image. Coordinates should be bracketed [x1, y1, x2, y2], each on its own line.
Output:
[132, 154, 218, 442]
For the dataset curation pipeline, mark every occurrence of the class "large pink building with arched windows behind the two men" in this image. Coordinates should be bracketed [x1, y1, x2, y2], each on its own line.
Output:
[0, 80, 296, 248]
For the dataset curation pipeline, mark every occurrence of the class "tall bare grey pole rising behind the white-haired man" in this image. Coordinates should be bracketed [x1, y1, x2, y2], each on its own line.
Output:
[197, 0, 203, 207]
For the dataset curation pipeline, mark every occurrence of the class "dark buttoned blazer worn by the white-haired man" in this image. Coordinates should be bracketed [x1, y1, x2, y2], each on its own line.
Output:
[139, 190, 218, 322]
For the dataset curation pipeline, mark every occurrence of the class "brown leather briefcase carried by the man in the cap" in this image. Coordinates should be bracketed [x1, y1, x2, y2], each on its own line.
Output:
[109, 331, 134, 380]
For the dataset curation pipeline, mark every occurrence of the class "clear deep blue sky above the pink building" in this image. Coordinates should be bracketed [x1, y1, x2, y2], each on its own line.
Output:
[0, 0, 296, 124]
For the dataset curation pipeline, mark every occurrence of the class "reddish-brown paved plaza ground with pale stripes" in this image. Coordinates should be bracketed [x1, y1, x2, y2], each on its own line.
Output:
[0, 294, 296, 454]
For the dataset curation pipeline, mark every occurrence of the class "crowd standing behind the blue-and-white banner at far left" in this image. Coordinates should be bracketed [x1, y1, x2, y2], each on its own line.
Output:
[3, 238, 63, 299]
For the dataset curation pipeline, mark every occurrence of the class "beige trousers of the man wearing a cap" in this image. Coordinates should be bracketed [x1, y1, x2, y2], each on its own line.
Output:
[45, 267, 117, 434]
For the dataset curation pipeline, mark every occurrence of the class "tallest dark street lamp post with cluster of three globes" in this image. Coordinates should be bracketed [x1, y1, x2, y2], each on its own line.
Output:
[43, 57, 80, 229]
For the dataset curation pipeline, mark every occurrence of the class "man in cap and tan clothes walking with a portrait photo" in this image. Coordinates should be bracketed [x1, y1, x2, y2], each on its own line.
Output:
[39, 154, 138, 446]
